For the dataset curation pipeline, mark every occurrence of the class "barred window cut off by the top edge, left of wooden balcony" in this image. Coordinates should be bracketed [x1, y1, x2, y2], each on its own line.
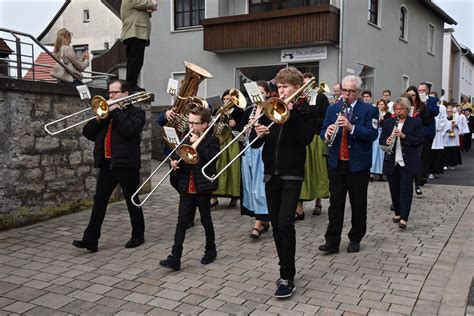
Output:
[174, 0, 204, 29]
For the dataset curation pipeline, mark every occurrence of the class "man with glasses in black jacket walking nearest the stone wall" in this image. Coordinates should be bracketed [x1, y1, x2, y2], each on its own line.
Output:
[72, 80, 146, 252]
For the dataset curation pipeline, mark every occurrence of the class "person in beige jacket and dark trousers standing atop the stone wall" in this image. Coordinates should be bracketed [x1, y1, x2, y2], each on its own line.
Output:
[120, 0, 158, 92]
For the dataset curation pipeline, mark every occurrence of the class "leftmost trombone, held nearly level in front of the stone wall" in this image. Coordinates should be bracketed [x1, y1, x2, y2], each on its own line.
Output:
[44, 91, 151, 136]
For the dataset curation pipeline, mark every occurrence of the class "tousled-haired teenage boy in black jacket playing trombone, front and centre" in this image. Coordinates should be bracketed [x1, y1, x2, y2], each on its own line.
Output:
[251, 67, 317, 298]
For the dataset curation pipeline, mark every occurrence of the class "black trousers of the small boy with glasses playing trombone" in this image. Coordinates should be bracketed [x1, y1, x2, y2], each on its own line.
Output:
[171, 193, 216, 258]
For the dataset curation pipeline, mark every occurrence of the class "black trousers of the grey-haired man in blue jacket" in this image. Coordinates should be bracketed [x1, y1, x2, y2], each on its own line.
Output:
[324, 161, 370, 246]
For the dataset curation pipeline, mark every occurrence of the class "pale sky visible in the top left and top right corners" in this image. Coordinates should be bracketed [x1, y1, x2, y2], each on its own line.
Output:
[0, 0, 474, 51]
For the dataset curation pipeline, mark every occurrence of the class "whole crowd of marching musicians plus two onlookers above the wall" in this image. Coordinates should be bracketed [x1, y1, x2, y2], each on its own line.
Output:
[55, 0, 474, 298]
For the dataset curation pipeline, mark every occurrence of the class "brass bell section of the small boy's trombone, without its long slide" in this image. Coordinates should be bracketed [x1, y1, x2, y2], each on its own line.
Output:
[177, 89, 247, 165]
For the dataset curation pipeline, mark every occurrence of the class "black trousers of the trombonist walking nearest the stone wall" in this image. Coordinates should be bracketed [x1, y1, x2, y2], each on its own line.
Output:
[83, 165, 145, 243]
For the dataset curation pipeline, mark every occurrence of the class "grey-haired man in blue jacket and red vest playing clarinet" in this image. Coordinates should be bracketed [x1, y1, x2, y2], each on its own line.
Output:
[319, 76, 379, 253]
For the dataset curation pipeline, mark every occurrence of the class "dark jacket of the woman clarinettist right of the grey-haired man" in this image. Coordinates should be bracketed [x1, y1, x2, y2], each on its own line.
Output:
[380, 117, 423, 176]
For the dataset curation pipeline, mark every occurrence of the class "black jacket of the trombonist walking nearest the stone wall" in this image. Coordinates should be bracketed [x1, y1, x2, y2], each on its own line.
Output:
[82, 105, 146, 168]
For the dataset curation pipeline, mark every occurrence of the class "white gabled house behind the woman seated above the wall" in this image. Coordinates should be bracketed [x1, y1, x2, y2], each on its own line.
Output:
[38, 0, 122, 71]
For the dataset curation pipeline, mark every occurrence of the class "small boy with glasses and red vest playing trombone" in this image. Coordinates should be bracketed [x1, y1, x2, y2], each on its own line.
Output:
[160, 107, 220, 271]
